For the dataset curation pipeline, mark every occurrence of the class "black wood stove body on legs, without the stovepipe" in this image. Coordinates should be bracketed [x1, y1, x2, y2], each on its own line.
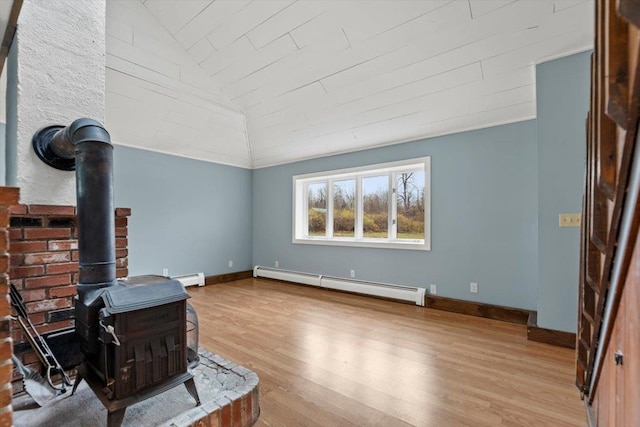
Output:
[73, 276, 200, 426]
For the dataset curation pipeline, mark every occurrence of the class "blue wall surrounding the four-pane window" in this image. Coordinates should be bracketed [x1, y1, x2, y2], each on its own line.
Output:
[253, 121, 538, 310]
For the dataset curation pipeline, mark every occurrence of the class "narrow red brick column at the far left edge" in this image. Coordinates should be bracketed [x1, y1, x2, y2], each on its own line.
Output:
[0, 187, 19, 426]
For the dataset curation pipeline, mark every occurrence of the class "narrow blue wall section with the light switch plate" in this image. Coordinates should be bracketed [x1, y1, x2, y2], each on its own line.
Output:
[536, 52, 590, 332]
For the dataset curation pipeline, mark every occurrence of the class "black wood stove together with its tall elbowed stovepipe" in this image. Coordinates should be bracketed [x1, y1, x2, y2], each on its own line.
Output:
[33, 119, 200, 426]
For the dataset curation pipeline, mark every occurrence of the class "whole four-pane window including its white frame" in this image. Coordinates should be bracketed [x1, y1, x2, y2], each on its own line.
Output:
[293, 157, 431, 250]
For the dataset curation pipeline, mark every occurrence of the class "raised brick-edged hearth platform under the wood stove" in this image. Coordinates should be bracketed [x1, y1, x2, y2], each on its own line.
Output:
[13, 349, 260, 427]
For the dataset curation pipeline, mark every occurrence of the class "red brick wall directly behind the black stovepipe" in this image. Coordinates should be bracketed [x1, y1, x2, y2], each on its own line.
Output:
[9, 205, 131, 391]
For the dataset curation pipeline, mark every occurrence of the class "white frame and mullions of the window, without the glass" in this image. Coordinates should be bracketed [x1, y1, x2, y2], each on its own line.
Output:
[292, 156, 431, 251]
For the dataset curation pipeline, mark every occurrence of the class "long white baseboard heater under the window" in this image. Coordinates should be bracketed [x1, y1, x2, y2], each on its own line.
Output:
[253, 265, 426, 306]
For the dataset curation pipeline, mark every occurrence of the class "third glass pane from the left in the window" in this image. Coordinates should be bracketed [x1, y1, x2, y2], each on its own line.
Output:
[362, 175, 389, 239]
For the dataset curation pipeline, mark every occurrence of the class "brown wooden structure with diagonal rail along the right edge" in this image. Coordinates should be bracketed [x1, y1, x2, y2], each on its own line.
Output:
[576, 0, 640, 426]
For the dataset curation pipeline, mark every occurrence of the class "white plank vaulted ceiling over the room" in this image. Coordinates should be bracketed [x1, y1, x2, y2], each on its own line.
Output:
[106, 0, 594, 168]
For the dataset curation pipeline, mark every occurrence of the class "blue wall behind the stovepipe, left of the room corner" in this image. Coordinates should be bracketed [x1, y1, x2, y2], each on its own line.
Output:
[114, 146, 252, 276]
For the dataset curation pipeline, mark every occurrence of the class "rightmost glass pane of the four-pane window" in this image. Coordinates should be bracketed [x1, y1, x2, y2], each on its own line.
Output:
[396, 171, 424, 239]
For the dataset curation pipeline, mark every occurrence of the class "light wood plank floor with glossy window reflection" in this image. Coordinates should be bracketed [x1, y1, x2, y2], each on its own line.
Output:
[189, 279, 586, 427]
